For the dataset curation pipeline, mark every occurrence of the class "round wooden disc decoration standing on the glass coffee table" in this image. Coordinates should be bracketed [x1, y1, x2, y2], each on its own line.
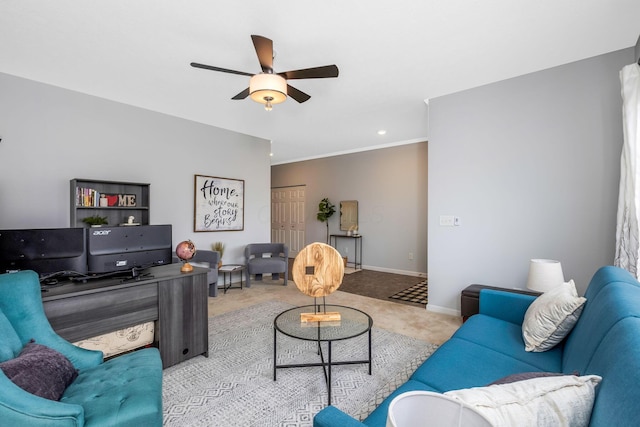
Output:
[291, 243, 344, 298]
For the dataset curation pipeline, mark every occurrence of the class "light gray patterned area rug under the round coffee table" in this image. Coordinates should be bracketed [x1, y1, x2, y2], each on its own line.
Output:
[163, 301, 437, 427]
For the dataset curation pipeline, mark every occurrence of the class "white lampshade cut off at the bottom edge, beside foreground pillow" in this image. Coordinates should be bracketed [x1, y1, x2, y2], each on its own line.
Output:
[387, 391, 491, 427]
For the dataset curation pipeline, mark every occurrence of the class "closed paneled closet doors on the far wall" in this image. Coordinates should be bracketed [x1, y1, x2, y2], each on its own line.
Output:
[271, 185, 306, 258]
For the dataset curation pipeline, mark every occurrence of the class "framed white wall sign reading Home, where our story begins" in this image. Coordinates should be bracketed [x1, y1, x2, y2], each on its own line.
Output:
[193, 175, 244, 231]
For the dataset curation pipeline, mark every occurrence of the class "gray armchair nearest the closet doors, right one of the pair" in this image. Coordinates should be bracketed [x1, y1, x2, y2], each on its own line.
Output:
[244, 243, 289, 287]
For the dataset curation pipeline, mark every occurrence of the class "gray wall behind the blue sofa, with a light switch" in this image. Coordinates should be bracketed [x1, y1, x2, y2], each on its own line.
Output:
[428, 48, 634, 312]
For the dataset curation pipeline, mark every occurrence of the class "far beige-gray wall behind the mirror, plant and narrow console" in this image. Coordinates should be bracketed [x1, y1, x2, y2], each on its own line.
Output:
[271, 142, 427, 275]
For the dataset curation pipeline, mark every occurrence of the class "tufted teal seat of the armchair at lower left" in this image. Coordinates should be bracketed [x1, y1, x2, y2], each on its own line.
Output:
[60, 348, 162, 427]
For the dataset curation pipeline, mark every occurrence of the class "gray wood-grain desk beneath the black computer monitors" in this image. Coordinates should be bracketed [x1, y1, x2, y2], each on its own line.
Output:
[42, 264, 209, 368]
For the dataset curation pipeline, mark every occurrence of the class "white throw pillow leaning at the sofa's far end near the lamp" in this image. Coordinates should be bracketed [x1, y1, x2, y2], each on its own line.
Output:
[522, 280, 586, 352]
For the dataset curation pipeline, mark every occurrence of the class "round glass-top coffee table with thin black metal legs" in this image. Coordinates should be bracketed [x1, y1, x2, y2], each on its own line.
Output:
[273, 305, 373, 405]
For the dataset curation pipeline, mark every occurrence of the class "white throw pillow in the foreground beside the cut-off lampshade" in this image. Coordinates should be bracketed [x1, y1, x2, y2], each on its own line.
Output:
[444, 375, 602, 427]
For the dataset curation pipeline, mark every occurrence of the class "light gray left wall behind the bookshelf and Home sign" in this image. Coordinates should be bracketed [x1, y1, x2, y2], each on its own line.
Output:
[0, 74, 270, 262]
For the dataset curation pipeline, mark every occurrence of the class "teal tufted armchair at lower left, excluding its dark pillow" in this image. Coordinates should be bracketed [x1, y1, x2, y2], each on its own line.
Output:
[0, 271, 162, 427]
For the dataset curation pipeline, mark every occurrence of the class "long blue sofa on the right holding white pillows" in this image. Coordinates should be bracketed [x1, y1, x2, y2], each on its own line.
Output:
[313, 266, 640, 427]
